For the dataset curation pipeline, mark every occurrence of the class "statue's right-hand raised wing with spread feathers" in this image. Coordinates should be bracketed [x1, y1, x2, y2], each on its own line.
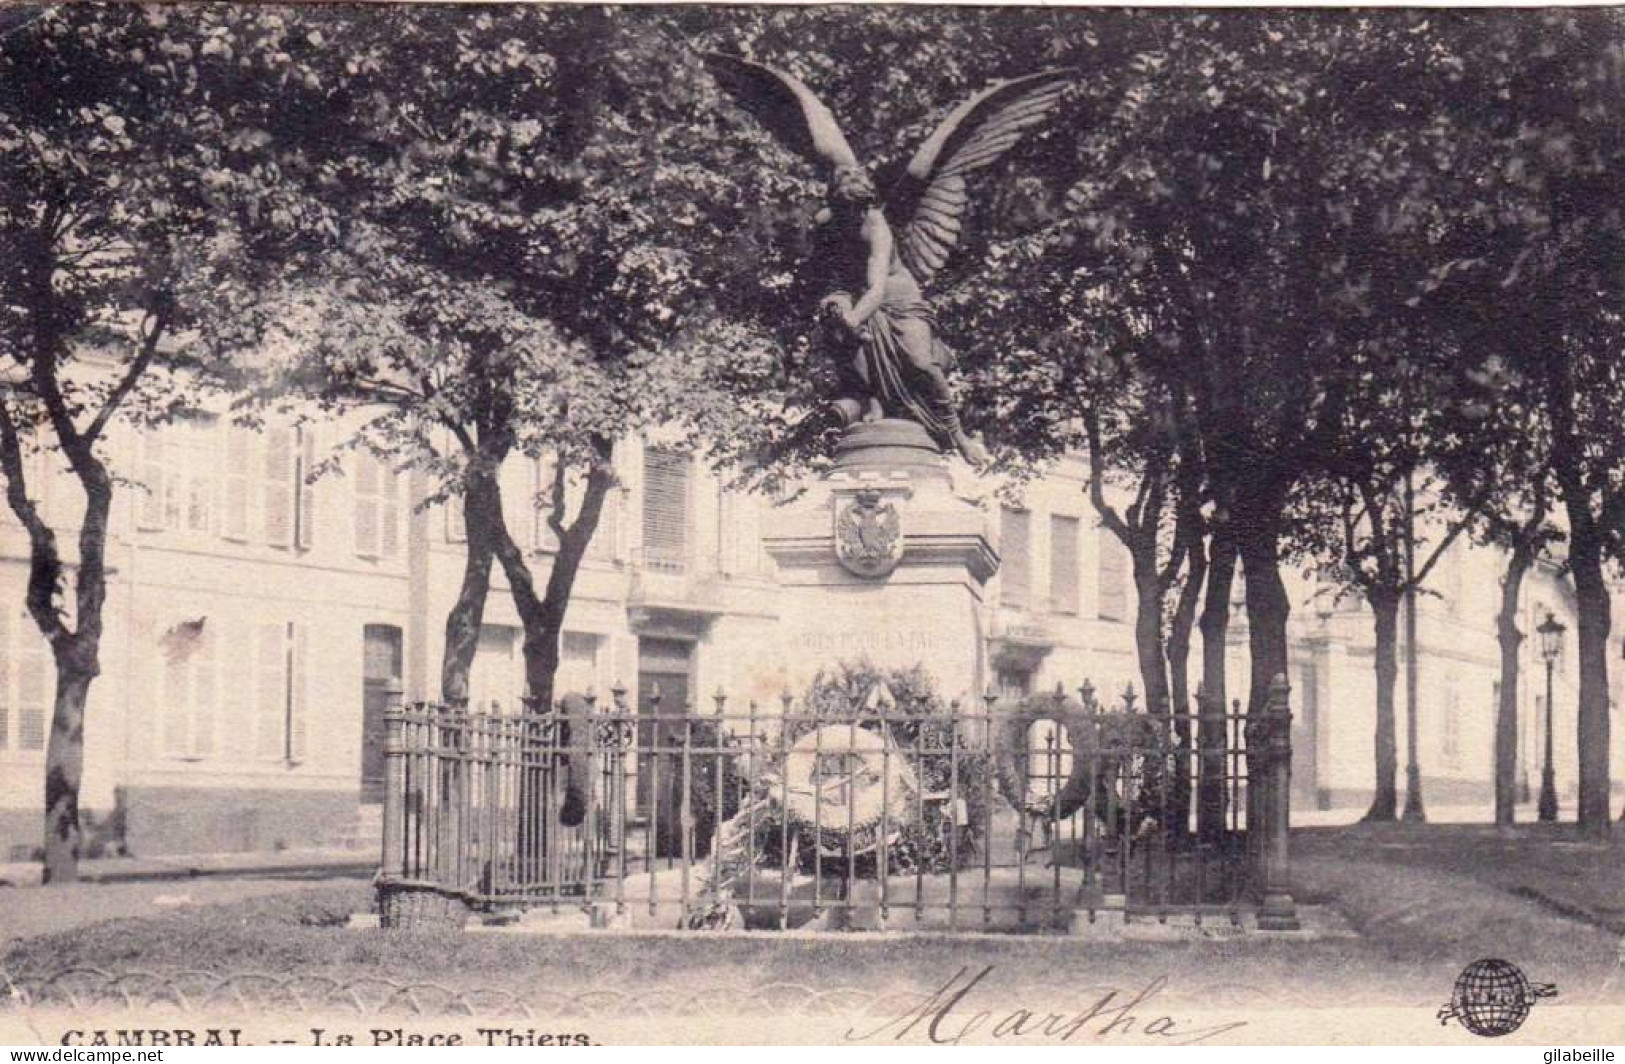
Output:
[886, 70, 1076, 284]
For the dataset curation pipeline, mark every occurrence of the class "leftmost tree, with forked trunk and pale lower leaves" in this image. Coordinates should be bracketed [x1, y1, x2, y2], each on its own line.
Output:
[0, 8, 310, 884]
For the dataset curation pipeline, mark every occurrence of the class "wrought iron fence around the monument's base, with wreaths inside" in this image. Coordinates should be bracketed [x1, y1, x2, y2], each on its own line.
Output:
[379, 681, 1295, 931]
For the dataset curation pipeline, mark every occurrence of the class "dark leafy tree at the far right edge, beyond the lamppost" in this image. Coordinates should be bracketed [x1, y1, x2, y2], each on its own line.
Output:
[1417, 10, 1625, 835]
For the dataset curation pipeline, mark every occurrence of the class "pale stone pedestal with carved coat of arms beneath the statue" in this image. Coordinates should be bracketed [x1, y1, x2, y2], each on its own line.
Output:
[764, 419, 998, 710]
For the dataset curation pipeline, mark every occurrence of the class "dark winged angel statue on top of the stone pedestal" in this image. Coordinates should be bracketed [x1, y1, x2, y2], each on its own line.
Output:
[705, 54, 1074, 465]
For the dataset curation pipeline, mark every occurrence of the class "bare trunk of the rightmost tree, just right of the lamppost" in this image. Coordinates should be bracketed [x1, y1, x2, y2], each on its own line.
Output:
[1547, 484, 1610, 835]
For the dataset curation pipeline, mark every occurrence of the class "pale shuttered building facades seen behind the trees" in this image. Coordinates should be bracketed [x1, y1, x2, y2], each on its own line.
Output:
[0, 414, 1625, 859]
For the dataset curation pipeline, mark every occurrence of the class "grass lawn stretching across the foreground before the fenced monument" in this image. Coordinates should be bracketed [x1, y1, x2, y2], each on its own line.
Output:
[0, 827, 1625, 1007]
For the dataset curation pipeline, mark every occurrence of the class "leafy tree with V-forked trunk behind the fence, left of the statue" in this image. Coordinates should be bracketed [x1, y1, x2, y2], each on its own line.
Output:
[230, 8, 777, 721]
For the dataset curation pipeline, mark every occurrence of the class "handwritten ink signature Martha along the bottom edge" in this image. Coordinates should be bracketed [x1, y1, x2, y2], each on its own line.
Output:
[847, 965, 1246, 1046]
